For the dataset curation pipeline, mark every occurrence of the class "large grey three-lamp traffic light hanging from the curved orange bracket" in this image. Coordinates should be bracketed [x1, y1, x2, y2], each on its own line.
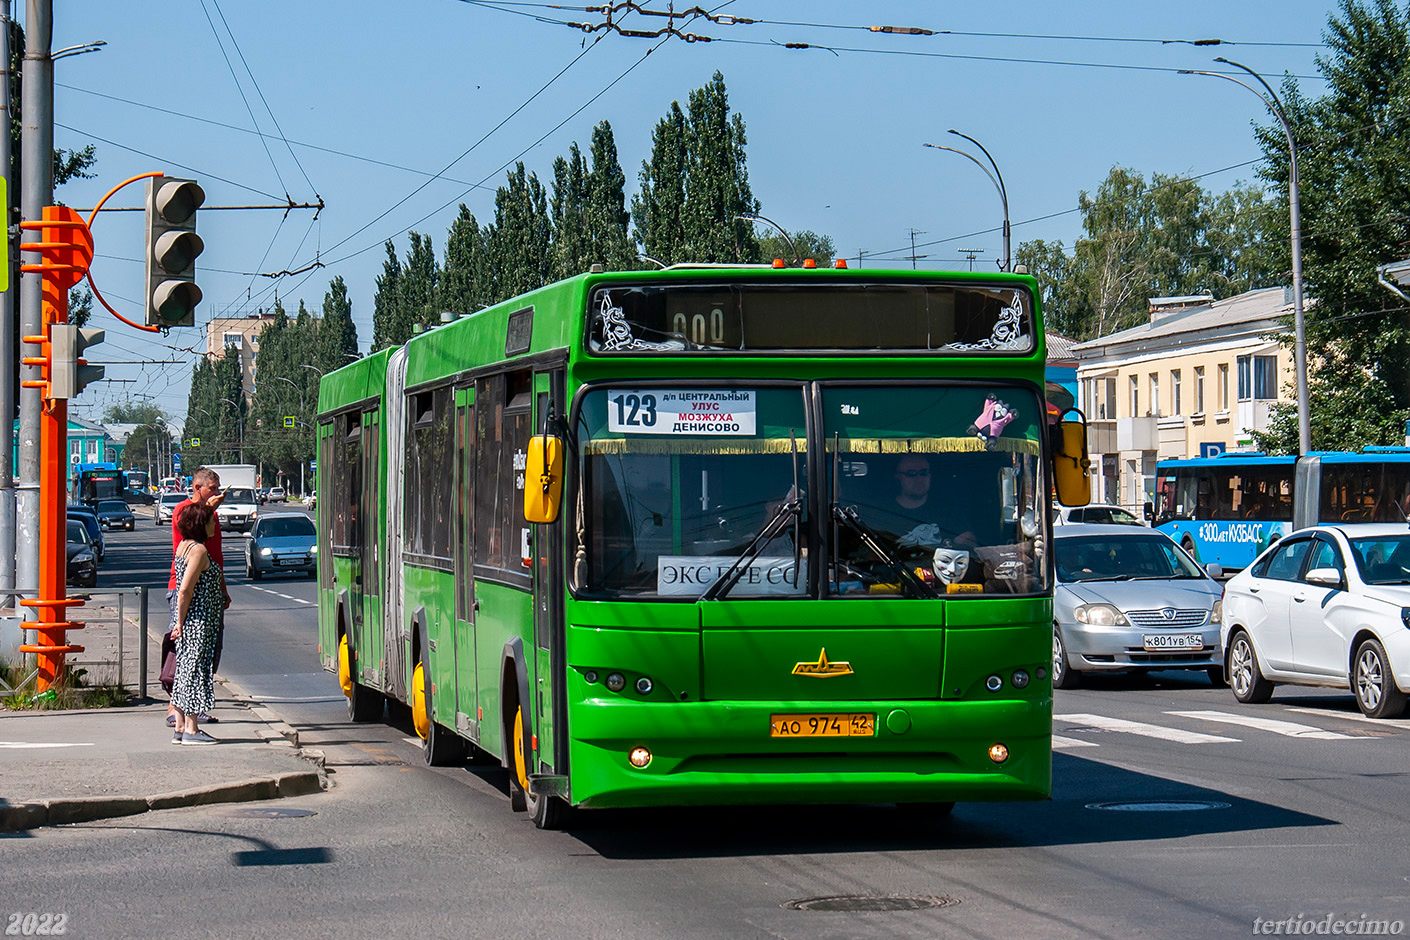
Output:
[147, 176, 206, 327]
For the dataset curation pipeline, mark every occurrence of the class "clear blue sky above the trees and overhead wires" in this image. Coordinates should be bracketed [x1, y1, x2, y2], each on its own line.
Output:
[49, 0, 1332, 419]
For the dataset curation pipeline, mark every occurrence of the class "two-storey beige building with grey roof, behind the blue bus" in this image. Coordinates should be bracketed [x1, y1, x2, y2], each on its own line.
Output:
[1074, 287, 1293, 512]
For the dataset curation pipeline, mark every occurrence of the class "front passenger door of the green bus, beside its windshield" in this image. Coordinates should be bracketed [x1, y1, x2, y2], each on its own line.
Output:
[520, 369, 568, 774]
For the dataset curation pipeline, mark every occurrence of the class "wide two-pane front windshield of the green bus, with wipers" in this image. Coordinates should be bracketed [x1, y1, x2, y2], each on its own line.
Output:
[572, 385, 1045, 600]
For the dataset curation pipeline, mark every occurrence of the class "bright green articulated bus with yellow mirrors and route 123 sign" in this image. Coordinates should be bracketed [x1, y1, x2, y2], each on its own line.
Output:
[317, 265, 1087, 829]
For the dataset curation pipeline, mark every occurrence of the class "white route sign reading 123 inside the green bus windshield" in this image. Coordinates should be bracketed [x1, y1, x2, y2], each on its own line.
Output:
[608, 389, 759, 435]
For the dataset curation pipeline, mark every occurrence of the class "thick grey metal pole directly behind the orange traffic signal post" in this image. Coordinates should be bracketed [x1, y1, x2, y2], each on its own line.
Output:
[16, 0, 51, 653]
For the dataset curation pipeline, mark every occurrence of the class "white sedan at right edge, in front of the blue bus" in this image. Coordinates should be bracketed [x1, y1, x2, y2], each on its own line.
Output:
[1221, 523, 1410, 719]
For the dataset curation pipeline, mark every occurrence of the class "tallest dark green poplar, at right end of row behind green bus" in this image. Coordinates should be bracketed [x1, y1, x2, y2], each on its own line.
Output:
[684, 72, 760, 264]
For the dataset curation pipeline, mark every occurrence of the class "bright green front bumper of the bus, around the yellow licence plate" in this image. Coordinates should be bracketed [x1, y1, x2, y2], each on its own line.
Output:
[570, 698, 1052, 808]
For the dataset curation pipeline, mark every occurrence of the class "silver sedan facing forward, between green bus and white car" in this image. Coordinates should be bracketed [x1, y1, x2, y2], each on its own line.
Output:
[1053, 524, 1224, 689]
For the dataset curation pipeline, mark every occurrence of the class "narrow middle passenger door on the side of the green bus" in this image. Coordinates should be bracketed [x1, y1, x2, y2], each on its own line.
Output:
[453, 388, 481, 741]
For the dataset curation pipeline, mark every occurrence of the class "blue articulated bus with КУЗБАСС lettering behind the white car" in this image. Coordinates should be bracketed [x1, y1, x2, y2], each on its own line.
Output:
[1155, 447, 1410, 571]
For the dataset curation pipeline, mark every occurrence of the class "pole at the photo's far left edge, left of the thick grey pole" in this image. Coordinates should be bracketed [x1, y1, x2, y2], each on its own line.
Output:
[0, 0, 15, 662]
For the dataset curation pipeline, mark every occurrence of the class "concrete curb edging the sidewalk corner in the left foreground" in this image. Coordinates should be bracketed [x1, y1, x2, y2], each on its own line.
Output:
[0, 771, 324, 833]
